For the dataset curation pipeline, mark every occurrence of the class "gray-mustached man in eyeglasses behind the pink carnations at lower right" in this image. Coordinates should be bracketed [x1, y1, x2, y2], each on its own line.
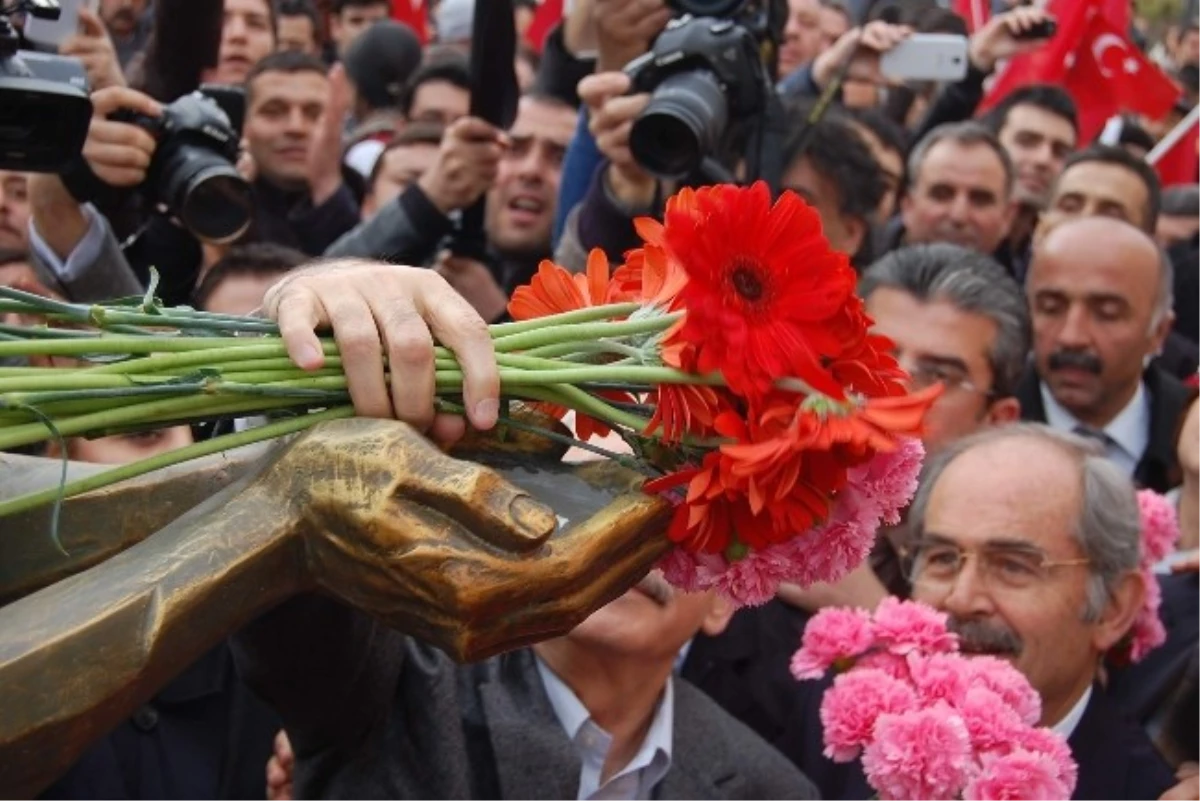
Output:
[906, 423, 1175, 801]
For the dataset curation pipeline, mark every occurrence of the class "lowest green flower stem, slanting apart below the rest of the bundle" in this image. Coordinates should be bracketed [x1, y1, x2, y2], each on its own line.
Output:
[0, 406, 354, 517]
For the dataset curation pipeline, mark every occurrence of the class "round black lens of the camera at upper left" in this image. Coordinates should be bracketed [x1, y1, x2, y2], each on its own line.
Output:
[158, 144, 253, 245]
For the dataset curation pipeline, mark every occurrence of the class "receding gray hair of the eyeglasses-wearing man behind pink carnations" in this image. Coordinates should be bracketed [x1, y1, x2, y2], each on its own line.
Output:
[908, 423, 1141, 622]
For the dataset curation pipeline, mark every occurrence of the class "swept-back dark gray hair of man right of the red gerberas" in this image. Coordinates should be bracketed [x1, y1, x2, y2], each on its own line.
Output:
[858, 242, 1033, 398]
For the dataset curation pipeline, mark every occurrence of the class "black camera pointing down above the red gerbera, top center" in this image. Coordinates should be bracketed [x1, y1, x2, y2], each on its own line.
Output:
[625, 0, 787, 179]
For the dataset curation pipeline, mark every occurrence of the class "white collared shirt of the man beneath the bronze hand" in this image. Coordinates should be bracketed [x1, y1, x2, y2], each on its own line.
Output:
[536, 660, 674, 801]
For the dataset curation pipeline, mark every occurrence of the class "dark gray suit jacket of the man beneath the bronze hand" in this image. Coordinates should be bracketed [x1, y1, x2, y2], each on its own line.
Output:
[235, 597, 820, 801]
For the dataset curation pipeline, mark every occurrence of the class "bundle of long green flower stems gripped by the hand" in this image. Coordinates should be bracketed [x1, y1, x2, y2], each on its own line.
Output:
[0, 282, 696, 525]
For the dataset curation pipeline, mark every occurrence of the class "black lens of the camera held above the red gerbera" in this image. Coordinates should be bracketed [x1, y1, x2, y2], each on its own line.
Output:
[629, 70, 728, 179]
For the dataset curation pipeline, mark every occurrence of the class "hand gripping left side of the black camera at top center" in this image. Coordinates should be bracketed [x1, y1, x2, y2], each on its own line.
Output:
[580, 72, 656, 209]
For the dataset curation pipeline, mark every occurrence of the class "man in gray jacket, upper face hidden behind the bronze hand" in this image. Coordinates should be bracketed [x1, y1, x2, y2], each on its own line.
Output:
[238, 565, 820, 801]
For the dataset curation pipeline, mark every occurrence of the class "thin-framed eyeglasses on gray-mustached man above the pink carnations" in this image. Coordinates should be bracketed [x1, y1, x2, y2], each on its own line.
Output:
[901, 541, 1091, 592]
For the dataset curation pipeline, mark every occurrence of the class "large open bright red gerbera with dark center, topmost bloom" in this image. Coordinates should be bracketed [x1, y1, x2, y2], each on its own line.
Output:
[654, 182, 854, 398]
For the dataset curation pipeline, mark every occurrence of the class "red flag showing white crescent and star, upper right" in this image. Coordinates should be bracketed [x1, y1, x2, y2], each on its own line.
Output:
[1062, 13, 1180, 141]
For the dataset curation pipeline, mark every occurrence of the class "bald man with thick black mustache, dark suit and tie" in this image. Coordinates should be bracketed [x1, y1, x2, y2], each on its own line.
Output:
[1018, 217, 1187, 492]
